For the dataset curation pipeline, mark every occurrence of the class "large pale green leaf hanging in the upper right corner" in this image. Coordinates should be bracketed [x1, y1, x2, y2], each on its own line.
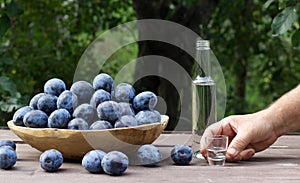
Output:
[271, 6, 298, 35]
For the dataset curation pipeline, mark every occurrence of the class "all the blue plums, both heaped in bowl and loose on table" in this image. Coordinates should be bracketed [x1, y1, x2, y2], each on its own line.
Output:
[0, 73, 192, 175]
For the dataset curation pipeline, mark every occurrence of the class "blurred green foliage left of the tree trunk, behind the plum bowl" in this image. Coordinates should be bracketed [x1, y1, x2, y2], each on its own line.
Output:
[0, 0, 137, 124]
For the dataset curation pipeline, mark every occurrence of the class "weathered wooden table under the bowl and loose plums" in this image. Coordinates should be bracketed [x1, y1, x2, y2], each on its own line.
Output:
[0, 130, 300, 183]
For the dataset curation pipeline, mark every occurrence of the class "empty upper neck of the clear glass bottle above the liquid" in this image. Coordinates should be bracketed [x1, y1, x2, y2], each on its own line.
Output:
[196, 39, 211, 78]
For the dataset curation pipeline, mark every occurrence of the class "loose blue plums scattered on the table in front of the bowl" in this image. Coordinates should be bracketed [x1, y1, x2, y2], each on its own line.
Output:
[0, 140, 192, 176]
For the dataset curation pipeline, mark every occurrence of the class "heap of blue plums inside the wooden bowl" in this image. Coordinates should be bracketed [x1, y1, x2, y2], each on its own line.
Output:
[13, 73, 161, 130]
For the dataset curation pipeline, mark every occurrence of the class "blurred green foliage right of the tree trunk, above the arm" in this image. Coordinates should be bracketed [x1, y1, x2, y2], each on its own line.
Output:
[210, 0, 300, 115]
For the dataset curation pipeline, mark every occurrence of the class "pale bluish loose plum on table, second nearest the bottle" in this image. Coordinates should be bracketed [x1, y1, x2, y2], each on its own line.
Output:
[137, 144, 162, 167]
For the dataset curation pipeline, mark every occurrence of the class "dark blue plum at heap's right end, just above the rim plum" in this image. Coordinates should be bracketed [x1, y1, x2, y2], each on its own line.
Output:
[133, 91, 157, 111]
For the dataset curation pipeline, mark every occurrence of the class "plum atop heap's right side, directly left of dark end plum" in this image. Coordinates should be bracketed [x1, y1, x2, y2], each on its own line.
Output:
[112, 83, 135, 103]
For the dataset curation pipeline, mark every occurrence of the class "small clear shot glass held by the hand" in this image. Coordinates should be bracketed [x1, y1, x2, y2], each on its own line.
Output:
[205, 135, 228, 166]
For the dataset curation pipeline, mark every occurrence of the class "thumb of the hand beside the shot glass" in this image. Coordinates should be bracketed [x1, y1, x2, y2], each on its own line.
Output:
[227, 134, 250, 159]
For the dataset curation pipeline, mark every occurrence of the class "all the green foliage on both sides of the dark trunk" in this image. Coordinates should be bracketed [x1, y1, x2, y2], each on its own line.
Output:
[0, 0, 300, 125]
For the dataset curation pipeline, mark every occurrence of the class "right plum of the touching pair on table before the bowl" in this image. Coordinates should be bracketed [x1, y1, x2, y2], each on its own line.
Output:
[101, 151, 129, 176]
